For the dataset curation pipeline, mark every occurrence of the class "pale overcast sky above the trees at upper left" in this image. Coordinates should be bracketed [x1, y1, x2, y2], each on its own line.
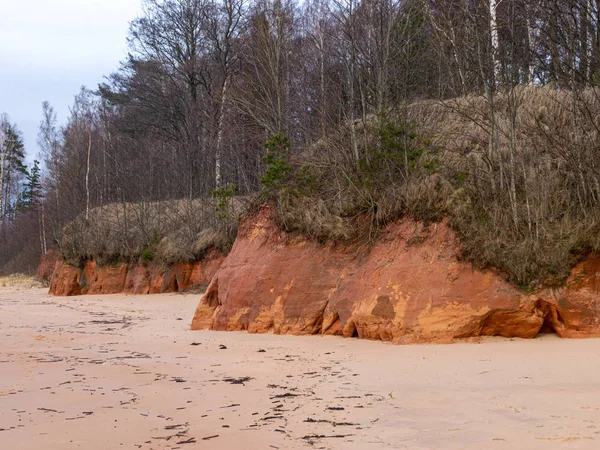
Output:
[0, 0, 141, 161]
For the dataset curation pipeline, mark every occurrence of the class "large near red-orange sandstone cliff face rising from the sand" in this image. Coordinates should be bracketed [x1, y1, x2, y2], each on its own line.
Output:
[192, 208, 600, 343]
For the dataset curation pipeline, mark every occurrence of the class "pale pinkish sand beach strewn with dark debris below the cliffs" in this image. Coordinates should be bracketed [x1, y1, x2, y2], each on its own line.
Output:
[0, 289, 600, 450]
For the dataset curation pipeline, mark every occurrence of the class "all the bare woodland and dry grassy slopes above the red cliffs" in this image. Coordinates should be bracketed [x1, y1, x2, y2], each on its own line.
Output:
[0, 0, 600, 289]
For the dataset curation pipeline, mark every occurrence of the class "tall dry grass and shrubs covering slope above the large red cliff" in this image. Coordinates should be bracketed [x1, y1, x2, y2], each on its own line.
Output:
[279, 87, 600, 289]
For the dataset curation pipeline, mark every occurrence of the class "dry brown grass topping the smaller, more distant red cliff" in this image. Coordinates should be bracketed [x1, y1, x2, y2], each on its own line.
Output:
[60, 198, 248, 264]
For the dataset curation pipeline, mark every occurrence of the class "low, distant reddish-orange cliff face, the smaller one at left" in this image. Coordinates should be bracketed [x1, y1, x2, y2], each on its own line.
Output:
[50, 249, 224, 296]
